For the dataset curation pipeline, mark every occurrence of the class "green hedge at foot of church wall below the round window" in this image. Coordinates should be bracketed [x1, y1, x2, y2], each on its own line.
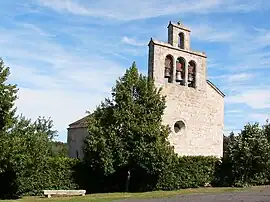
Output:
[156, 156, 219, 190]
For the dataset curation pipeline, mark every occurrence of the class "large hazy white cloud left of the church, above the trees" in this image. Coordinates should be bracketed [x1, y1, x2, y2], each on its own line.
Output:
[0, 17, 125, 141]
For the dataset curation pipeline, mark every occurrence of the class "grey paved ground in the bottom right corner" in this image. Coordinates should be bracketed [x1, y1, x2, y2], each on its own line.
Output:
[119, 187, 270, 202]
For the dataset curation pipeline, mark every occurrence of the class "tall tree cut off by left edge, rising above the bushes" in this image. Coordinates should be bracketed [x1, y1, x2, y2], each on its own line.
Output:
[0, 58, 18, 133]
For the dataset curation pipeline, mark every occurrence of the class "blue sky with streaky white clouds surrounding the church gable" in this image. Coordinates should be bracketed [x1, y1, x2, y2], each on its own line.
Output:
[0, 0, 270, 142]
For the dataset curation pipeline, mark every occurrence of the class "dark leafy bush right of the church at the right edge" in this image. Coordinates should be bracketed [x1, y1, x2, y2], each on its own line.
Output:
[217, 120, 270, 186]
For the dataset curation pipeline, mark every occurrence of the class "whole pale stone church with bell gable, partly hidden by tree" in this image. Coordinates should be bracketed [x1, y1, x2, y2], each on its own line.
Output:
[68, 22, 225, 158]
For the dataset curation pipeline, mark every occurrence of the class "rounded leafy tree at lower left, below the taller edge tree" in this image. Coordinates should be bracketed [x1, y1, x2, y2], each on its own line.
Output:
[0, 116, 50, 196]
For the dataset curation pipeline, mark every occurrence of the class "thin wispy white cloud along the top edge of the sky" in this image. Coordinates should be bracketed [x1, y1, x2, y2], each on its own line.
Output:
[35, 0, 266, 20]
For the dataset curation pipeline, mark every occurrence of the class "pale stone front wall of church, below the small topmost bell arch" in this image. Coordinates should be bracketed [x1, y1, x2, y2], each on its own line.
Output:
[149, 40, 224, 157]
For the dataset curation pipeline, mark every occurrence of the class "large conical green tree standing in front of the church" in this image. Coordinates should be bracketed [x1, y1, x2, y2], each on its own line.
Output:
[84, 63, 173, 192]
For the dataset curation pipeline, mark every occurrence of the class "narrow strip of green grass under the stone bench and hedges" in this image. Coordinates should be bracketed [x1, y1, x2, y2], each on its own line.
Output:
[0, 188, 253, 202]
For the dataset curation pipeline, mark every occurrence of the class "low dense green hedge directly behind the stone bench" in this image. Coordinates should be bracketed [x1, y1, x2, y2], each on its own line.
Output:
[0, 157, 78, 198]
